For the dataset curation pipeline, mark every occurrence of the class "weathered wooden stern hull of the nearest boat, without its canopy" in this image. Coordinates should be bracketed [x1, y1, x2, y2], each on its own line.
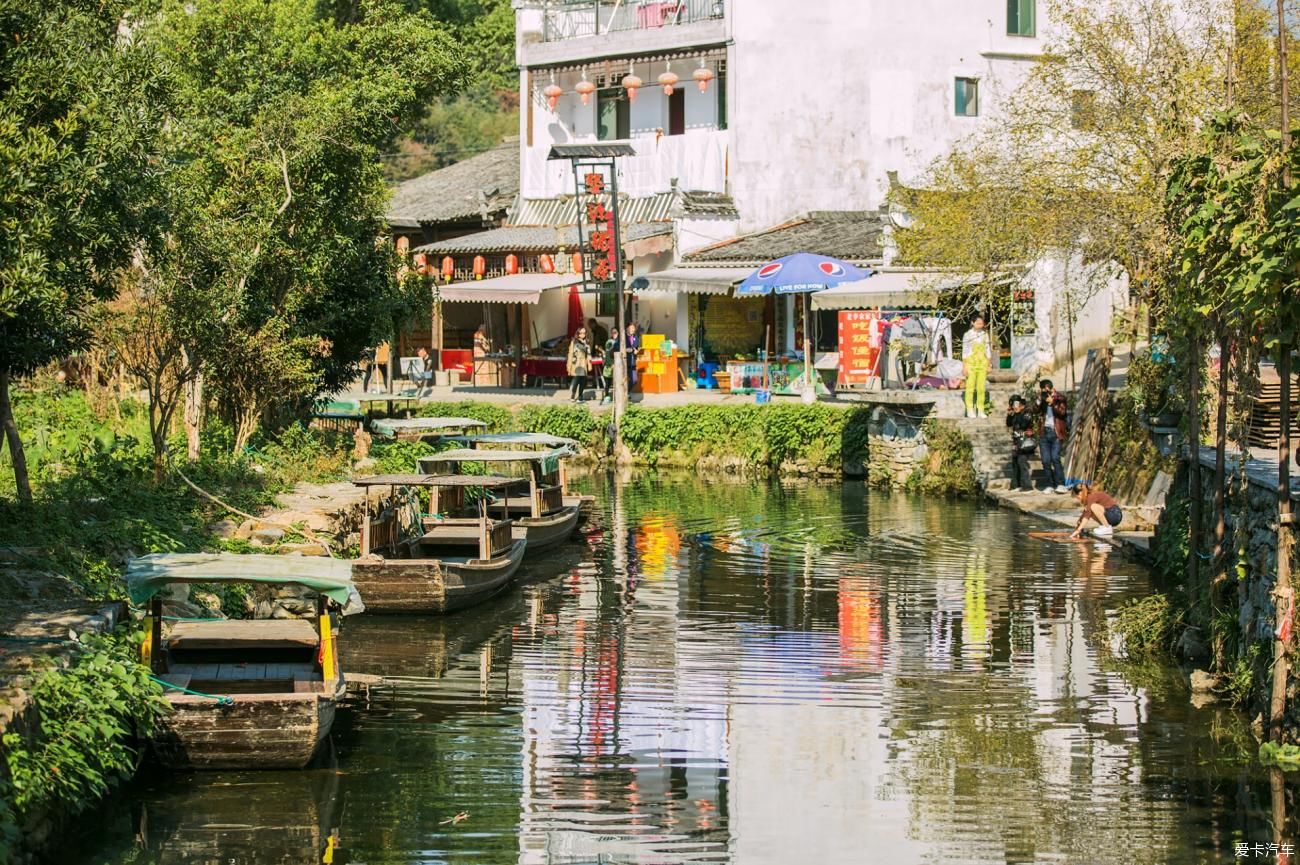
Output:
[152, 684, 345, 769]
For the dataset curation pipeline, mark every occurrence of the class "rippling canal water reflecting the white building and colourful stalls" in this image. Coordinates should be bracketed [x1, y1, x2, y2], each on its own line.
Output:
[56, 476, 1296, 865]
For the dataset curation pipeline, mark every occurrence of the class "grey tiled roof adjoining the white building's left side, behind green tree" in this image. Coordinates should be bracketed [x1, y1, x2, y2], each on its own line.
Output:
[387, 138, 519, 228]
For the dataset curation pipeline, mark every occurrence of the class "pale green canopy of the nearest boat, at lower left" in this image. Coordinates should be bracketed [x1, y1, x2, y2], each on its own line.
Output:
[126, 553, 365, 615]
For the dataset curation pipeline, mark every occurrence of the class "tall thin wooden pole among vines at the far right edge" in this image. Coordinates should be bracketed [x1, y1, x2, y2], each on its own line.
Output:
[1269, 0, 1295, 741]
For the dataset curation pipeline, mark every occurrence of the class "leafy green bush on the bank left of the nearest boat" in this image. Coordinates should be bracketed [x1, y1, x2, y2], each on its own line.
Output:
[4, 632, 168, 813]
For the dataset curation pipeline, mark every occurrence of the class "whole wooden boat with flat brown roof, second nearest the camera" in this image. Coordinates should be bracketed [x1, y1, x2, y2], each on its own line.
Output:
[352, 475, 527, 614]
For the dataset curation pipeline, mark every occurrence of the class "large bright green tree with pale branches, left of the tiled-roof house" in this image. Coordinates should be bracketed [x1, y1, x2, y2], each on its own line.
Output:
[146, 0, 464, 449]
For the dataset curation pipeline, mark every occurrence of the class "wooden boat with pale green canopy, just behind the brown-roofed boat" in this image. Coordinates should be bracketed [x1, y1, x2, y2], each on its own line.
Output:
[417, 447, 579, 552]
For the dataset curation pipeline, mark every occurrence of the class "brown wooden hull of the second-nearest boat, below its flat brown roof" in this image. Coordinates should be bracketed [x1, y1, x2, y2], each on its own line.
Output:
[352, 540, 525, 615]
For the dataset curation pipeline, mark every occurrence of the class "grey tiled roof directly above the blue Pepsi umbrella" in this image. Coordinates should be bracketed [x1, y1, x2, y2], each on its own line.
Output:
[683, 211, 884, 265]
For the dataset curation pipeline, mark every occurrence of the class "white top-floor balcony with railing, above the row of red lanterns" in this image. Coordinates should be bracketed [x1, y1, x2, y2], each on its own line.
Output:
[517, 0, 727, 66]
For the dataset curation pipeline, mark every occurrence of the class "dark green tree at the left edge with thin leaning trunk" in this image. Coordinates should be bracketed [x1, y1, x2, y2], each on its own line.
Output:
[0, 0, 165, 501]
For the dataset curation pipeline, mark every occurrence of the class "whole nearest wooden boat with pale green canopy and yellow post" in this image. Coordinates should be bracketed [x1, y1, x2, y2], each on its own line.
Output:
[126, 554, 364, 769]
